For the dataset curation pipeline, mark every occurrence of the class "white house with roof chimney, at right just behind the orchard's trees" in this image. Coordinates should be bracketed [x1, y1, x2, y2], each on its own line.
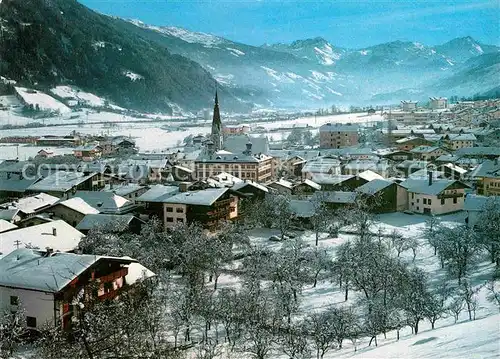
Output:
[401, 172, 470, 215]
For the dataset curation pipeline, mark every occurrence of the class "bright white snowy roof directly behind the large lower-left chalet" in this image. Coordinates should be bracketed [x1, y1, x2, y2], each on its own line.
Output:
[0, 220, 84, 255]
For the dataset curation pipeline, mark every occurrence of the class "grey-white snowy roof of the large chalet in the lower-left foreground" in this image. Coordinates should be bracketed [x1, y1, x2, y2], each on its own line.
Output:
[0, 248, 135, 293]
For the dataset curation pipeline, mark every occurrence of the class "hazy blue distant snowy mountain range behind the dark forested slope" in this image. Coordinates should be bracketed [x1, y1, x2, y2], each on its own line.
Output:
[131, 20, 500, 107]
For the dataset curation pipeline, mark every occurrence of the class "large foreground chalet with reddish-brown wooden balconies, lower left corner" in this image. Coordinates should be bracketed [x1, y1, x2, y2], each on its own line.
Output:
[0, 248, 154, 330]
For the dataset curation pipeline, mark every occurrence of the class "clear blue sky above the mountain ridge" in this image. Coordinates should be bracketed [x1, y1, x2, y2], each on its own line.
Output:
[79, 0, 500, 48]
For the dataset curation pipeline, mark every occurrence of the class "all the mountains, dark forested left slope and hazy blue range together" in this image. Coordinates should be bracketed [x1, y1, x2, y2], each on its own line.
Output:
[0, 0, 500, 112]
